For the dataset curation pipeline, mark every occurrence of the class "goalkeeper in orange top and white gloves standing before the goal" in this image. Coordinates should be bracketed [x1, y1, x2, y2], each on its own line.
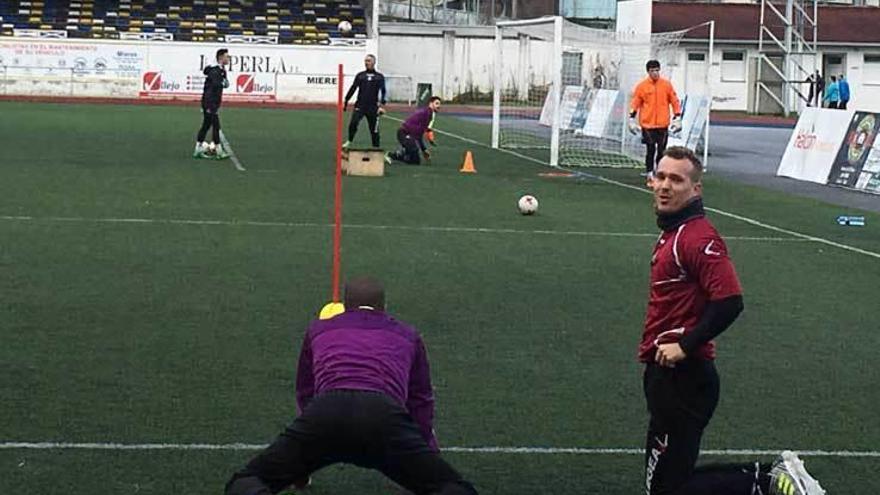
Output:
[629, 60, 681, 179]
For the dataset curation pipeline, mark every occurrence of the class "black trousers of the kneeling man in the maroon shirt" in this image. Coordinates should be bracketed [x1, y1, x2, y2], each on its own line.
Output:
[644, 359, 770, 495]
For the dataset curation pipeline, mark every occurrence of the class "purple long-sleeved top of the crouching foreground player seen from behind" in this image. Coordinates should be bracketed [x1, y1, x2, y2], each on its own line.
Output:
[296, 309, 438, 451]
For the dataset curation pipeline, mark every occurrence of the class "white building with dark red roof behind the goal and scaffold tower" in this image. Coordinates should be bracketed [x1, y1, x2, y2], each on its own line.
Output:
[652, 0, 880, 112]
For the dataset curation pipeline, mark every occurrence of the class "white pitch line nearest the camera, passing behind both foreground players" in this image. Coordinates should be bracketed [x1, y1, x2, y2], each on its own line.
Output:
[0, 442, 880, 458]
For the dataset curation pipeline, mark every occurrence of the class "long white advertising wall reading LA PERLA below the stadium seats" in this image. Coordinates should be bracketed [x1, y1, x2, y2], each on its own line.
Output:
[0, 38, 367, 103]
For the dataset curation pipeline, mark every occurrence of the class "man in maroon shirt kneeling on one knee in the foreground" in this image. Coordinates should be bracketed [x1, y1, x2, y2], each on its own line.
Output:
[639, 147, 825, 495]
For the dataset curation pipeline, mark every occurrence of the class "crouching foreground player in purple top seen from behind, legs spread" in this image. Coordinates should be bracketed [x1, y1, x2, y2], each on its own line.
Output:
[226, 278, 477, 495]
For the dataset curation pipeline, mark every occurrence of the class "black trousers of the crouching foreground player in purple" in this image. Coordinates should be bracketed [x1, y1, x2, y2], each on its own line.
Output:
[226, 390, 477, 495]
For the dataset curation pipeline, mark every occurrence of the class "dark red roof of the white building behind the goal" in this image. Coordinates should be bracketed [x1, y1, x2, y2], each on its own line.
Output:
[651, 2, 880, 44]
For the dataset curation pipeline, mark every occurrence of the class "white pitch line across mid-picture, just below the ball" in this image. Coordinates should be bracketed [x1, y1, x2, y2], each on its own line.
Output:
[0, 215, 807, 242]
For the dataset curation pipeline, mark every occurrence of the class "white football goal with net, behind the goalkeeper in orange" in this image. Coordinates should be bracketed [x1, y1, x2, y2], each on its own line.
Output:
[492, 17, 711, 167]
